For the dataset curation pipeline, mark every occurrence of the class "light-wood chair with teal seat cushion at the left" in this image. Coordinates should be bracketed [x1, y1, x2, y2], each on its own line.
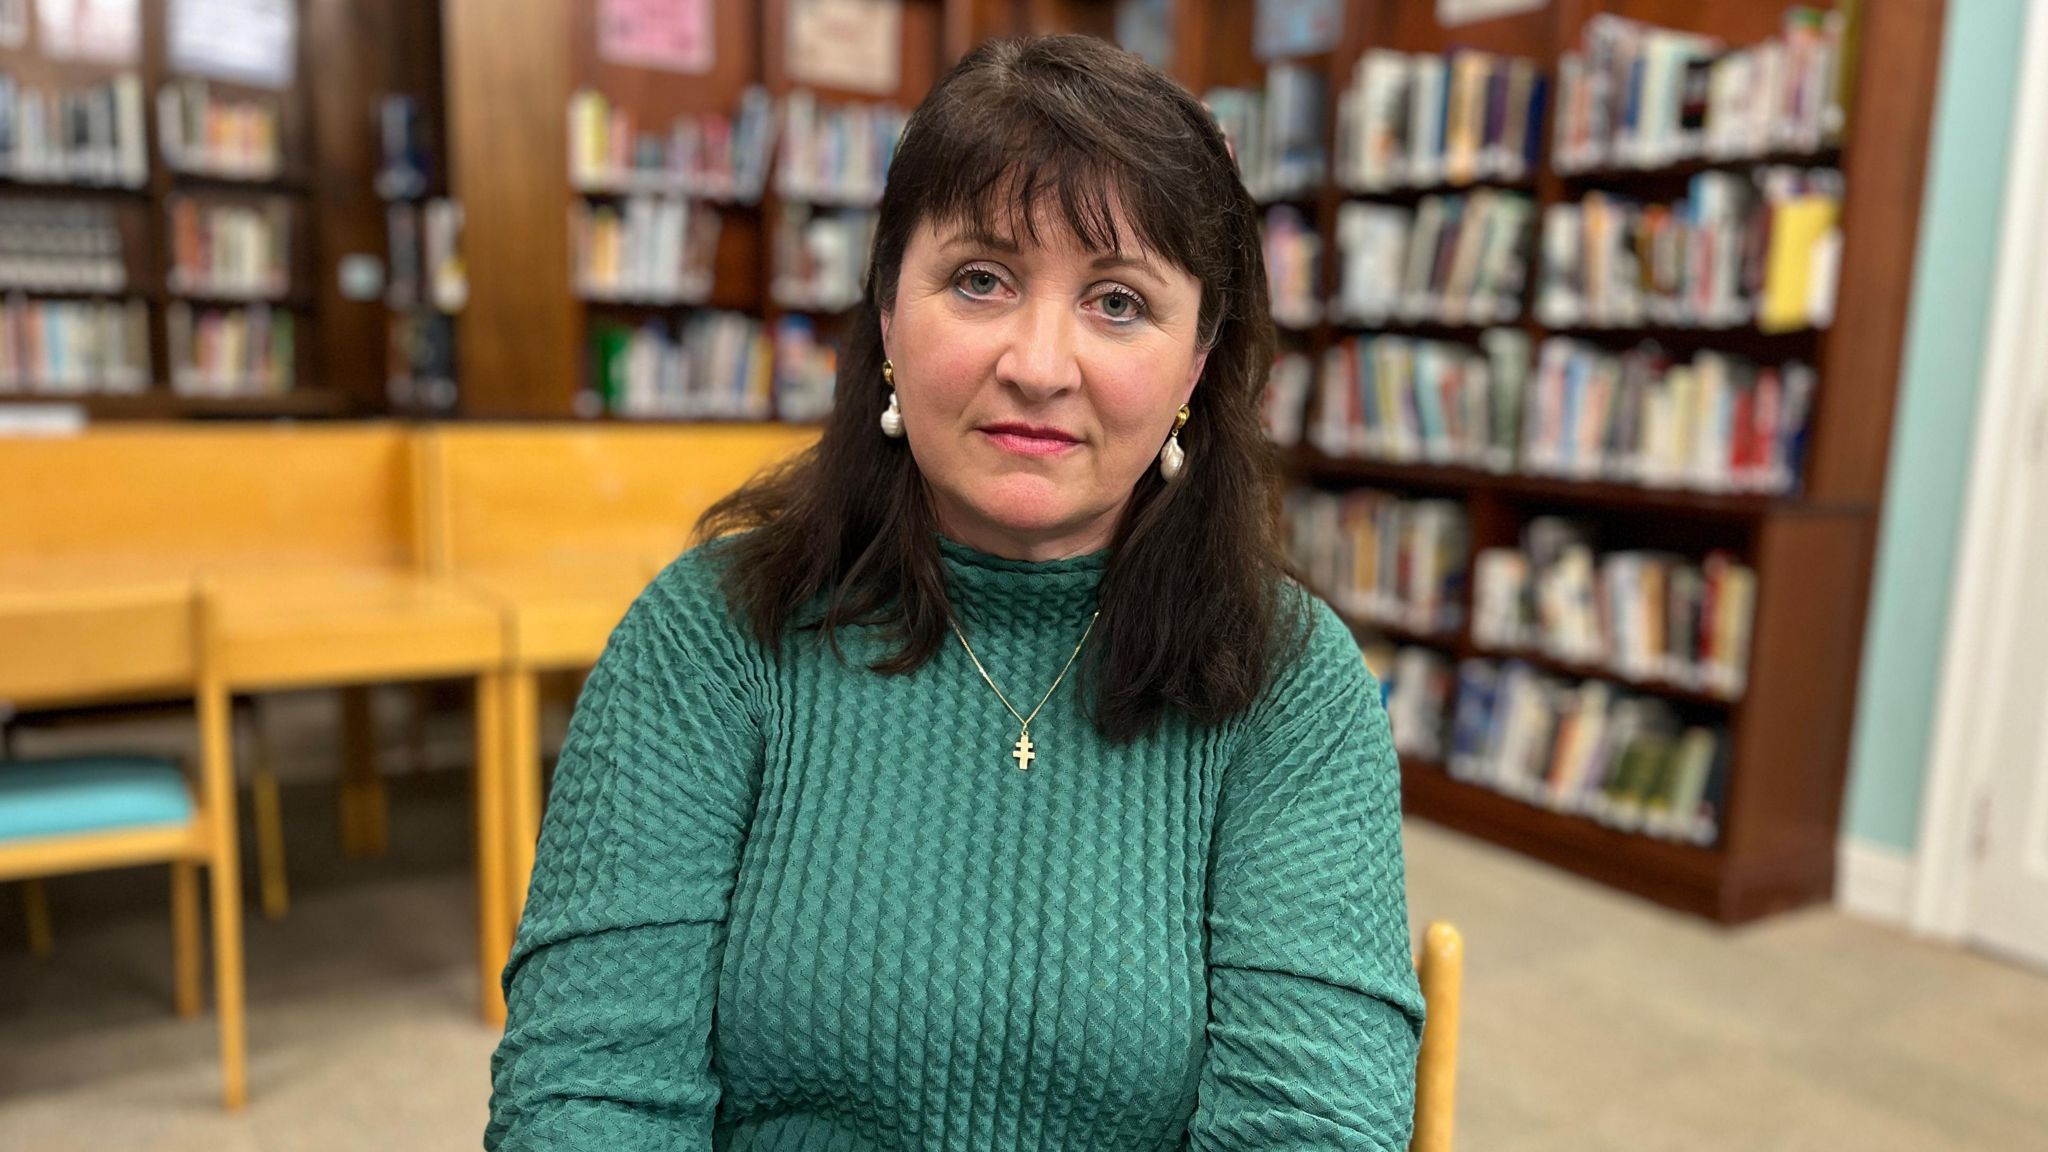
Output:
[0, 580, 248, 1109]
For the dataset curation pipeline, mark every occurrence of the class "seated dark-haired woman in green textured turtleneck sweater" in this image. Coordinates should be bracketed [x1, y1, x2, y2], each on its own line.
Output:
[487, 37, 1421, 1152]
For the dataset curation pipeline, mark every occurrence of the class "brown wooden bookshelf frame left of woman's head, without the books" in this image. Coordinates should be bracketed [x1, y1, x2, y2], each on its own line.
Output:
[442, 0, 946, 418]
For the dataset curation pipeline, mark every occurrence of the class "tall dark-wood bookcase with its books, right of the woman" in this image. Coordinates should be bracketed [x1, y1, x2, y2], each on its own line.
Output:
[1212, 0, 1939, 920]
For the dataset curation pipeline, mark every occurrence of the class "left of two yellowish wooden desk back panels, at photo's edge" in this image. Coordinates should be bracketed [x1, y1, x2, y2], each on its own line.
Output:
[0, 422, 420, 572]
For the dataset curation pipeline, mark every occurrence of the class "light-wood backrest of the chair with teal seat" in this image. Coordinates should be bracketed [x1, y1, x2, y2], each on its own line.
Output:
[0, 580, 201, 705]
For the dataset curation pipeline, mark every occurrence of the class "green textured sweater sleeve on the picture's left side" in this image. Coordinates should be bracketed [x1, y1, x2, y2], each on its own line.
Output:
[483, 558, 760, 1152]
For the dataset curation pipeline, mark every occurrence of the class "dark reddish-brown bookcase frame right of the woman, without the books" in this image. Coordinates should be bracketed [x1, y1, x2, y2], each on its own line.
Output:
[987, 0, 1944, 922]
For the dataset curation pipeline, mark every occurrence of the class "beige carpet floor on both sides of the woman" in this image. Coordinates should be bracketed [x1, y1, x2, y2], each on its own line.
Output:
[0, 773, 2048, 1152]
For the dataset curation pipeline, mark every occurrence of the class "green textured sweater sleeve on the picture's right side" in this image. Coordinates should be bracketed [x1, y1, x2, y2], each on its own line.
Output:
[1188, 601, 1423, 1152]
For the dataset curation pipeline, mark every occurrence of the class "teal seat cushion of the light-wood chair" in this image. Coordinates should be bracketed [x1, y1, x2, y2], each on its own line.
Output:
[0, 756, 193, 840]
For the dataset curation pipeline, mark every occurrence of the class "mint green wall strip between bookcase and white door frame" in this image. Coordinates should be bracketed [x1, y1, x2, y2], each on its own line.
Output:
[1843, 0, 2025, 853]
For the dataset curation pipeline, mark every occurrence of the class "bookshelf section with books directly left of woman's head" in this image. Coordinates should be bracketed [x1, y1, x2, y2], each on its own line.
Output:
[524, 0, 942, 422]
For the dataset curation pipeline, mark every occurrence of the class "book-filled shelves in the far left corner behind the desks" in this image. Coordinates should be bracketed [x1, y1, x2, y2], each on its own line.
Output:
[0, 0, 338, 418]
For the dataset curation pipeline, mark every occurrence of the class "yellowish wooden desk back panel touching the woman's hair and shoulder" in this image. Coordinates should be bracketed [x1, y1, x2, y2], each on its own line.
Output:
[424, 424, 817, 574]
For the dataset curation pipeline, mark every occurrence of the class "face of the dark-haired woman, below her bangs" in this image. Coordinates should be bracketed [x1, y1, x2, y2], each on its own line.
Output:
[877, 213, 1206, 560]
